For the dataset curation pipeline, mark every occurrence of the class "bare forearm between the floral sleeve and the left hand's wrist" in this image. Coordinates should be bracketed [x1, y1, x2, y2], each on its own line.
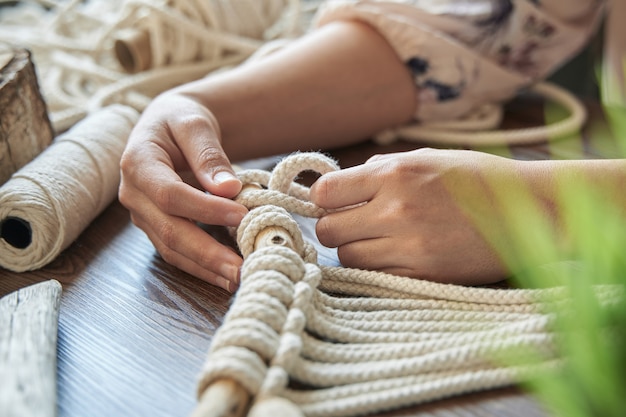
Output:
[168, 22, 416, 160]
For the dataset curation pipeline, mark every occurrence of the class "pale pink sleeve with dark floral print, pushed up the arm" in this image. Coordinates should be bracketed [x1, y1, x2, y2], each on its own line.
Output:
[315, 0, 605, 121]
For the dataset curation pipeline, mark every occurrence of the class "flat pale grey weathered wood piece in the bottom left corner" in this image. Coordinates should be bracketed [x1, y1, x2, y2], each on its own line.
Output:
[0, 280, 61, 417]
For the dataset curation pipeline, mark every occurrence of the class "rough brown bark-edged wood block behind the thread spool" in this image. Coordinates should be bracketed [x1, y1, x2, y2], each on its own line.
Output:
[0, 43, 54, 184]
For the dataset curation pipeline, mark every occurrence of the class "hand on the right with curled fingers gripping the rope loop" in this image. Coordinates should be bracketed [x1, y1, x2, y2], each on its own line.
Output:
[311, 149, 515, 284]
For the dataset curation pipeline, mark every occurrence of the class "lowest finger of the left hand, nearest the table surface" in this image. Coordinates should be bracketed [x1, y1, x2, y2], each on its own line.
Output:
[133, 210, 242, 289]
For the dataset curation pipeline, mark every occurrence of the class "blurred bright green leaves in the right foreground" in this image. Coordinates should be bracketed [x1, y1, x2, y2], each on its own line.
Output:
[500, 59, 626, 417]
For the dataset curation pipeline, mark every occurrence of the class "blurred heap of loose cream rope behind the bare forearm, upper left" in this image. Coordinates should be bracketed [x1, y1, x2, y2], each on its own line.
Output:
[0, 0, 316, 132]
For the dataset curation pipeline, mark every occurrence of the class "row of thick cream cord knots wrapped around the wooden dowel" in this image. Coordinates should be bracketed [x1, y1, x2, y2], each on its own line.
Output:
[198, 198, 322, 396]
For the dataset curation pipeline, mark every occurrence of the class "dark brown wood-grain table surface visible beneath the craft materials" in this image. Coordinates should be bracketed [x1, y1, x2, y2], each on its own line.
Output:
[0, 96, 615, 417]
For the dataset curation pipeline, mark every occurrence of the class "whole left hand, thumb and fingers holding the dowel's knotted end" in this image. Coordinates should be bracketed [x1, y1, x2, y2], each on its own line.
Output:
[119, 92, 247, 292]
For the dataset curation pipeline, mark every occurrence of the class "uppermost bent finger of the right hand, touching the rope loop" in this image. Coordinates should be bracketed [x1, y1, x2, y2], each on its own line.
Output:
[310, 165, 380, 210]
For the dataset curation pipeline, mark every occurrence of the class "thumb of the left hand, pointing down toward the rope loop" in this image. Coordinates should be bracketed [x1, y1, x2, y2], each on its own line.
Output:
[170, 105, 242, 198]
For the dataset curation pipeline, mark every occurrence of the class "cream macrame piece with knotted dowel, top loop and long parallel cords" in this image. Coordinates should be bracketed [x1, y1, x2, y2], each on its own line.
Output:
[193, 153, 623, 417]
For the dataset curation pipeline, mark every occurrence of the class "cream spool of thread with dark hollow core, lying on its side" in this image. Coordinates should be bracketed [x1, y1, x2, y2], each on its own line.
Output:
[0, 105, 139, 272]
